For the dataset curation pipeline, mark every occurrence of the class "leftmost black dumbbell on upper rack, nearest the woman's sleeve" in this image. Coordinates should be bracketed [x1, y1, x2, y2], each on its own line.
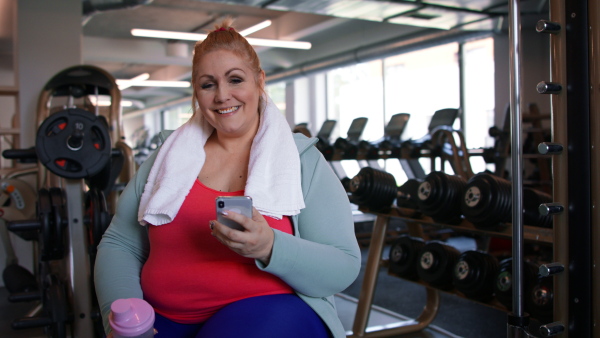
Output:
[349, 167, 398, 212]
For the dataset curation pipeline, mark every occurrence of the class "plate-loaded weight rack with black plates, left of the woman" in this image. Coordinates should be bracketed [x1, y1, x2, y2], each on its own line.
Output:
[3, 65, 136, 337]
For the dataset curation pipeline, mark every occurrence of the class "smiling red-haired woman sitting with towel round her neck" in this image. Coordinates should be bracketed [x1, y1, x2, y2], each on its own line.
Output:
[95, 21, 360, 338]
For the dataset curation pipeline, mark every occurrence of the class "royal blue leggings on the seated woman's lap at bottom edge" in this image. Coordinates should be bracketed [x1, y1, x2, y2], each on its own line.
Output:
[154, 294, 331, 338]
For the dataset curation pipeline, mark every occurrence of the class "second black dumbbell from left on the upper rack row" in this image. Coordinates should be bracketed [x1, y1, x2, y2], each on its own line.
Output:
[417, 171, 467, 224]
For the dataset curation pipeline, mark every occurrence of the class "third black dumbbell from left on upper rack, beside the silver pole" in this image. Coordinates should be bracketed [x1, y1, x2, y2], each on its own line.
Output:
[461, 173, 512, 230]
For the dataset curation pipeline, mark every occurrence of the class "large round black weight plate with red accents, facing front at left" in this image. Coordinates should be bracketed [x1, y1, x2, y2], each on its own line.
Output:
[35, 108, 111, 179]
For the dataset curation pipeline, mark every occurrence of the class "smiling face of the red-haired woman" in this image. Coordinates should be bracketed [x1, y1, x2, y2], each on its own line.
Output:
[194, 50, 264, 137]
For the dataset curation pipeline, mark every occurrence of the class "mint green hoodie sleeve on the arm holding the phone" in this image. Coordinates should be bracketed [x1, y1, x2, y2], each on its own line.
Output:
[257, 147, 361, 297]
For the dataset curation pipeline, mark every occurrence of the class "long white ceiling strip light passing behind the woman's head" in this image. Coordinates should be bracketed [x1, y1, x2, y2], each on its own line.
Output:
[131, 28, 312, 49]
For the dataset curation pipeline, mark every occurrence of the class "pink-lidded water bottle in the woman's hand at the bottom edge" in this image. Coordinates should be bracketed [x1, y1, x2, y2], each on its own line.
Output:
[108, 298, 154, 338]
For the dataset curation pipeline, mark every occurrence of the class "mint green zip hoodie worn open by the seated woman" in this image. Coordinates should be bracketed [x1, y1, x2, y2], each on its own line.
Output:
[94, 132, 361, 338]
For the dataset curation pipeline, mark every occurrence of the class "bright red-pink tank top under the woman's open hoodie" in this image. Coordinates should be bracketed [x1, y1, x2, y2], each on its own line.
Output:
[141, 180, 294, 324]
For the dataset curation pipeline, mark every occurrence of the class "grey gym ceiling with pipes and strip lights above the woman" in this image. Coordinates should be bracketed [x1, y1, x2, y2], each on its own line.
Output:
[11, 0, 547, 113]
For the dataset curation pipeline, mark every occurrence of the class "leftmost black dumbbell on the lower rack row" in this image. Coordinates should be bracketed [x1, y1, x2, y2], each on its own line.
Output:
[389, 235, 425, 280]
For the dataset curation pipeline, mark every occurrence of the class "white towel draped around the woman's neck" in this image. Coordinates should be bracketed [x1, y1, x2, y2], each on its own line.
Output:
[138, 97, 304, 225]
